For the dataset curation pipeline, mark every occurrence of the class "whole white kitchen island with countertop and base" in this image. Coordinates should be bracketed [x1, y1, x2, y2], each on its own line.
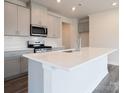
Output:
[23, 47, 116, 93]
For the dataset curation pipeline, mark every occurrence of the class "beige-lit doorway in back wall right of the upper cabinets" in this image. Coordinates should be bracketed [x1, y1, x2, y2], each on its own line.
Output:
[62, 22, 71, 49]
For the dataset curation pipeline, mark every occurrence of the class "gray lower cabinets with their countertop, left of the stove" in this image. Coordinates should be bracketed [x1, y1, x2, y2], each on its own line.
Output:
[4, 50, 33, 80]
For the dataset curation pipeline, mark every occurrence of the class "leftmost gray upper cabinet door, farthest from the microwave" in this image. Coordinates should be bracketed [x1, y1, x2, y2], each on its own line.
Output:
[5, 2, 18, 35]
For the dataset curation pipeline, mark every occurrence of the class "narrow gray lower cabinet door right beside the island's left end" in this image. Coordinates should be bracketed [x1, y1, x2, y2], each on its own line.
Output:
[21, 57, 28, 73]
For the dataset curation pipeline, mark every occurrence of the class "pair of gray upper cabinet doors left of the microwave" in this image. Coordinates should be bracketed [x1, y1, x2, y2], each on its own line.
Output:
[5, 2, 30, 36]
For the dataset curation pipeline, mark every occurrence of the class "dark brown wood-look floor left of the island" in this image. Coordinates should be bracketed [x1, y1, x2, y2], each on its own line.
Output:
[4, 75, 28, 93]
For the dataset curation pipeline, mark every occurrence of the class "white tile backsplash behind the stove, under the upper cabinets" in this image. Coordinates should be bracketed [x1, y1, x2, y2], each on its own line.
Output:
[4, 36, 62, 51]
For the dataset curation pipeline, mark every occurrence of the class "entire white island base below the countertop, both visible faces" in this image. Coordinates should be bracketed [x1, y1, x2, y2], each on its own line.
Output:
[28, 56, 108, 93]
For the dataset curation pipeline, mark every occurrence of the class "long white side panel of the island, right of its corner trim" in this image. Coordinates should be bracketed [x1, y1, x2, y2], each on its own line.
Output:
[50, 56, 108, 93]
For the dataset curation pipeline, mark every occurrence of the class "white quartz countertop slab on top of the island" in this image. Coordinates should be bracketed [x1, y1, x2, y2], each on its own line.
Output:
[23, 47, 116, 70]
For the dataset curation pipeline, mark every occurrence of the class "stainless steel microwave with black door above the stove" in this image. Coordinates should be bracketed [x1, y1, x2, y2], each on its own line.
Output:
[30, 25, 48, 37]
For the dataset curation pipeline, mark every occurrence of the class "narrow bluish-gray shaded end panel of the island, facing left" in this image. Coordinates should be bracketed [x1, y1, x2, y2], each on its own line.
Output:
[28, 60, 43, 93]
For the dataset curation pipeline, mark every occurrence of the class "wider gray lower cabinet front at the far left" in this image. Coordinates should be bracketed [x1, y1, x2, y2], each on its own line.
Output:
[4, 56, 20, 78]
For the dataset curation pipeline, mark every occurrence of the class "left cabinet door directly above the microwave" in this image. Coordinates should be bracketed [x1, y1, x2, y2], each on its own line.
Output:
[31, 3, 41, 26]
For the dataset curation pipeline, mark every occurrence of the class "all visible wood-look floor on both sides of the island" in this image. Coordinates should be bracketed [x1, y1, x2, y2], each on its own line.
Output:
[4, 65, 119, 93]
